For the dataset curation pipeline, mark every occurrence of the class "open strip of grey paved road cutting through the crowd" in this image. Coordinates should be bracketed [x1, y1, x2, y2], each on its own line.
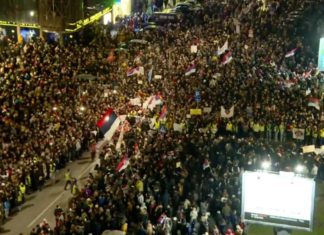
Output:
[0, 152, 98, 235]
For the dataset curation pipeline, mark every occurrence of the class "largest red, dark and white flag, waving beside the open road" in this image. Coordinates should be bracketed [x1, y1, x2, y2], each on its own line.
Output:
[97, 108, 120, 140]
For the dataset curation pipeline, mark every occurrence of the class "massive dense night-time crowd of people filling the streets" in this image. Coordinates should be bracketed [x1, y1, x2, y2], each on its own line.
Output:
[0, 0, 324, 235]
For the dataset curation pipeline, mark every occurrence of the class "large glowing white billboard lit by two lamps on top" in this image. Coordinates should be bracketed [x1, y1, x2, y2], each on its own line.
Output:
[242, 172, 315, 231]
